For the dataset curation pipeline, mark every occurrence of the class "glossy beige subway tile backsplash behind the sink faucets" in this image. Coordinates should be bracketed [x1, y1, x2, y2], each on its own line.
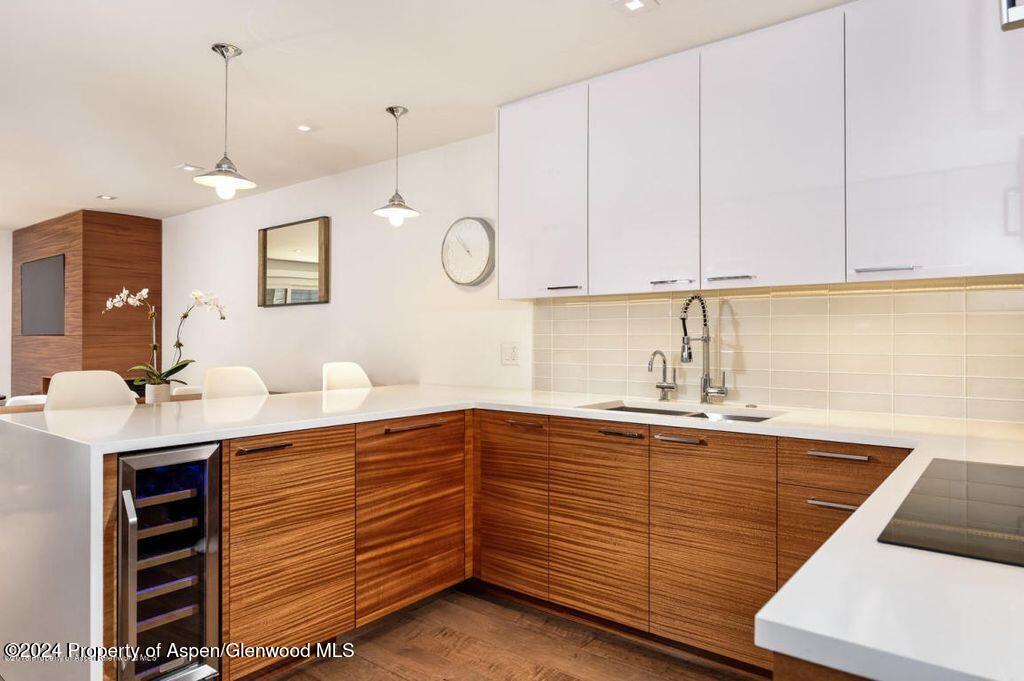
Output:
[534, 278, 1024, 421]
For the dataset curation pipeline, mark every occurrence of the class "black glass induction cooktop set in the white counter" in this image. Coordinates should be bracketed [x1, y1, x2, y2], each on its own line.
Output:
[879, 459, 1024, 566]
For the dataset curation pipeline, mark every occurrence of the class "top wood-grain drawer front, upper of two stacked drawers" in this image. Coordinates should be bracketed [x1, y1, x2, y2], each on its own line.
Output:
[778, 437, 910, 495]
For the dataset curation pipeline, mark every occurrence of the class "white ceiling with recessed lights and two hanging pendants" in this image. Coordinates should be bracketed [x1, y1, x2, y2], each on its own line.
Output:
[0, 0, 844, 228]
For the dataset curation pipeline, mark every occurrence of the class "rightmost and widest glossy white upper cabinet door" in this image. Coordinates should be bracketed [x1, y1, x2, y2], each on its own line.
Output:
[847, 0, 1024, 282]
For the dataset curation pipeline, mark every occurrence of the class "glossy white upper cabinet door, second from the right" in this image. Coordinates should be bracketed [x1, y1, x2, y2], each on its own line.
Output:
[700, 10, 846, 289]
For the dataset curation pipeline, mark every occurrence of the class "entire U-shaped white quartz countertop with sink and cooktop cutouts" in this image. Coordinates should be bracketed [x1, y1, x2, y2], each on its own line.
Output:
[6, 386, 1024, 680]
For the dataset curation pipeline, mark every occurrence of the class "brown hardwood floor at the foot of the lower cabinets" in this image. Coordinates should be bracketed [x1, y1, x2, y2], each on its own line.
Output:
[284, 591, 752, 681]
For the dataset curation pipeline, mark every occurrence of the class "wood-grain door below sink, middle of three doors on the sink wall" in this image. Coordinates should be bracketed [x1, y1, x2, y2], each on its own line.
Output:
[550, 419, 649, 631]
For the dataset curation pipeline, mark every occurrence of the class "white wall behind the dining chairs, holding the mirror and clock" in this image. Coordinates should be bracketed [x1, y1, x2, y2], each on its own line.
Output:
[163, 134, 532, 391]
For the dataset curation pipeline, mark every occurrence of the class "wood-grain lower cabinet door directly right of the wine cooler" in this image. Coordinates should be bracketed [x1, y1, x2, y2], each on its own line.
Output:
[223, 426, 355, 678]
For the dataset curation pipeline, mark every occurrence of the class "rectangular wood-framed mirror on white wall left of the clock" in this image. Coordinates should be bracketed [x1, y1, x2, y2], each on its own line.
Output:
[259, 217, 331, 307]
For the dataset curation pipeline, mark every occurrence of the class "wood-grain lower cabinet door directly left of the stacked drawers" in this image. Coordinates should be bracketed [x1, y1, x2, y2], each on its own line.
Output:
[650, 427, 775, 669]
